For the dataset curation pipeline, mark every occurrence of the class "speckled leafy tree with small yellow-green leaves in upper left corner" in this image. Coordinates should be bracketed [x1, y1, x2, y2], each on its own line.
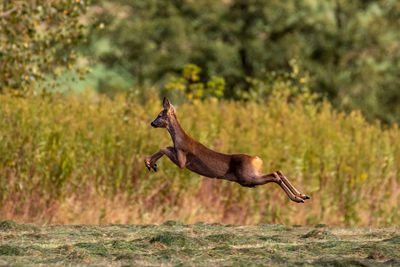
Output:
[0, 0, 87, 90]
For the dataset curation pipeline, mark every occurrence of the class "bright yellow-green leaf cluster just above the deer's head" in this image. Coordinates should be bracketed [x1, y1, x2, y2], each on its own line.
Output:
[165, 64, 225, 101]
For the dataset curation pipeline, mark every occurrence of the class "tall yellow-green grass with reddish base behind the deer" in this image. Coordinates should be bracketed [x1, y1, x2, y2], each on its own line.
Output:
[0, 90, 400, 225]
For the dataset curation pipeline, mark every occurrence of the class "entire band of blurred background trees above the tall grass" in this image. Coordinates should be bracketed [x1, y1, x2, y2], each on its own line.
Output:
[0, 0, 400, 123]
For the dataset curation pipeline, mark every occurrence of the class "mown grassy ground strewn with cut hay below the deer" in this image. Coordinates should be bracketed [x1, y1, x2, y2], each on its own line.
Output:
[0, 221, 400, 266]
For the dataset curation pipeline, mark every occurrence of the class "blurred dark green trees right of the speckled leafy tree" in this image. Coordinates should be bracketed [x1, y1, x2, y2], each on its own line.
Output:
[88, 0, 400, 123]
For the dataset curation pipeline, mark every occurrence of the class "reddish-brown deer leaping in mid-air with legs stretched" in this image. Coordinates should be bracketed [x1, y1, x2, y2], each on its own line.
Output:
[144, 97, 310, 203]
